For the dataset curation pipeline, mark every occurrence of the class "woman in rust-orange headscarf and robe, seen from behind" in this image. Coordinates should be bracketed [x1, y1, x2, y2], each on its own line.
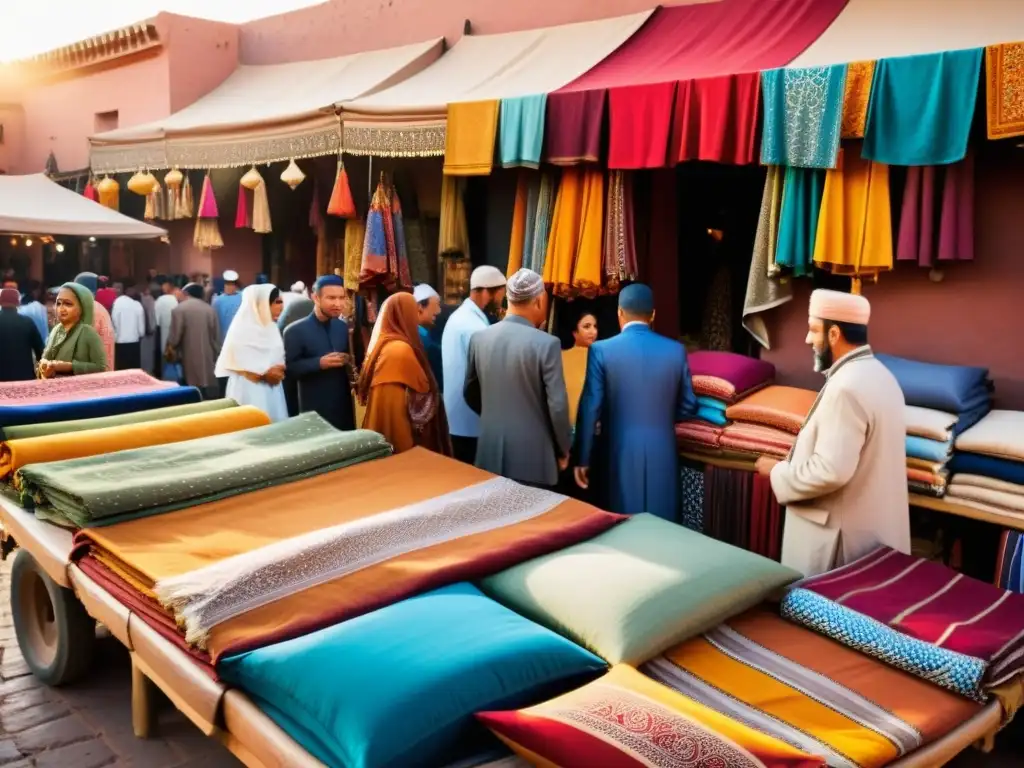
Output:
[358, 293, 452, 456]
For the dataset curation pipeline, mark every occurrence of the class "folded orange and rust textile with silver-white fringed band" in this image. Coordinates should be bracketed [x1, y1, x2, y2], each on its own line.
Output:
[69, 448, 622, 669]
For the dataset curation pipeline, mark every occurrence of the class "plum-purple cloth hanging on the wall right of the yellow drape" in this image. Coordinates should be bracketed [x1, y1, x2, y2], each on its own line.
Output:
[896, 153, 974, 268]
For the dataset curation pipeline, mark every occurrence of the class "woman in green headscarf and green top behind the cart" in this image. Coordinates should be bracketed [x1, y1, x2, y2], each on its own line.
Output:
[39, 283, 110, 379]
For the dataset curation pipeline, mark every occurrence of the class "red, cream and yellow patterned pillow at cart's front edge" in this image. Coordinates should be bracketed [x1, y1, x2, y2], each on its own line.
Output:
[476, 665, 825, 768]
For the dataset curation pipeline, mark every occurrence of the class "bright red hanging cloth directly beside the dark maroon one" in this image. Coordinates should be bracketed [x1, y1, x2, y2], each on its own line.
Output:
[608, 83, 676, 170]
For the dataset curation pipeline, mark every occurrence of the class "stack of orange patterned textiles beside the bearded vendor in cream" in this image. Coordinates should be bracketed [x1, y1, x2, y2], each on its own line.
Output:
[720, 385, 817, 459]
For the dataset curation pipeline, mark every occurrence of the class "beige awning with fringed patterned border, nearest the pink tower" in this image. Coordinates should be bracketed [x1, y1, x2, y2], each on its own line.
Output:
[90, 38, 444, 173]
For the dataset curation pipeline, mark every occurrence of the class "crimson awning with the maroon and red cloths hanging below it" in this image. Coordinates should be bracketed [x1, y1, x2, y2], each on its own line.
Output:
[546, 0, 848, 169]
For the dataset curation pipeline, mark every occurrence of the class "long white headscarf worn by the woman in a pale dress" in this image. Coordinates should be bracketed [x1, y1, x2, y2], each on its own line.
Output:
[214, 284, 285, 378]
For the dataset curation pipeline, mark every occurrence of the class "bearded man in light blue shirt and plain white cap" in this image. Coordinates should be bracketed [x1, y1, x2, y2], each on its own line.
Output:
[441, 265, 505, 464]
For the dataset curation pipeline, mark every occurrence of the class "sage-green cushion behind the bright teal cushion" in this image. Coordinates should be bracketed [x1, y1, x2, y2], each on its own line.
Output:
[482, 514, 800, 664]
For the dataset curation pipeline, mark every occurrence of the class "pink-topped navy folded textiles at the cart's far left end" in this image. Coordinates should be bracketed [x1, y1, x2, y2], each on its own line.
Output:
[0, 371, 202, 430]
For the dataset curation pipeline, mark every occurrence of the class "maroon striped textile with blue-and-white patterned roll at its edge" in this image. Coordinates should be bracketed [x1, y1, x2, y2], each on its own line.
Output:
[781, 547, 1024, 719]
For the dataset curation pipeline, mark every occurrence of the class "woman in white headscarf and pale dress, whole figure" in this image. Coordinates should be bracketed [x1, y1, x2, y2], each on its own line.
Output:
[214, 285, 288, 421]
